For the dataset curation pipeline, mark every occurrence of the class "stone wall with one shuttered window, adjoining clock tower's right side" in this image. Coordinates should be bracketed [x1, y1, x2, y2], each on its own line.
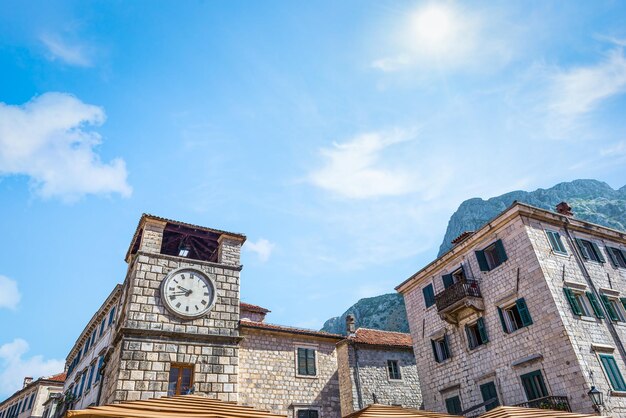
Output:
[239, 328, 341, 418]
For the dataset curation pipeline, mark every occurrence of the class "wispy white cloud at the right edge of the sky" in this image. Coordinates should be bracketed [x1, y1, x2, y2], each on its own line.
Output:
[548, 48, 626, 118]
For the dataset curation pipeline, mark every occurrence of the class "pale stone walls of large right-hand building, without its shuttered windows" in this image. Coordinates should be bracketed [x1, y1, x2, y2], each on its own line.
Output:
[398, 204, 626, 416]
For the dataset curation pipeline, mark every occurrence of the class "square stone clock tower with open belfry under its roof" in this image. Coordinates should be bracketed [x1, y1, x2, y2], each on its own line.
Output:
[100, 214, 246, 404]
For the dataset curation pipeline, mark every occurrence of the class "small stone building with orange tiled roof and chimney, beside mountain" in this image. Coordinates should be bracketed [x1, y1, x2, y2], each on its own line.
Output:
[337, 324, 422, 416]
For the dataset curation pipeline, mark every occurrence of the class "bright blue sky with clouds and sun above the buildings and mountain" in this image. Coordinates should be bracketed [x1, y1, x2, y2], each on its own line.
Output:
[0, 0, 626, 396]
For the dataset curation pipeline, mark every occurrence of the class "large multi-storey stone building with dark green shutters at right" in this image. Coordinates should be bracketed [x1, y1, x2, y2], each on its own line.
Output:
[397, 202, 626, 416]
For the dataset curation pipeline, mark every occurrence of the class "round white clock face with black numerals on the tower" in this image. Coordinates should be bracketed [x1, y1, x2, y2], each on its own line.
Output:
[161, 268, 215, 319]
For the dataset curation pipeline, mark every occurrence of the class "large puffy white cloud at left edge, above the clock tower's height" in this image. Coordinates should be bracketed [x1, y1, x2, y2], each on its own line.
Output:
[0, 93, 132, 200]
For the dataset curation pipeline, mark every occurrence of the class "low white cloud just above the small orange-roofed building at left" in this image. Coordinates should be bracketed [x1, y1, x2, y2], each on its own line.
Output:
[0, 338, 65, 396]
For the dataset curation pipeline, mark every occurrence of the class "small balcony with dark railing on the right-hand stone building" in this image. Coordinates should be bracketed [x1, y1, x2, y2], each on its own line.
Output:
[435, 279, 485, 324]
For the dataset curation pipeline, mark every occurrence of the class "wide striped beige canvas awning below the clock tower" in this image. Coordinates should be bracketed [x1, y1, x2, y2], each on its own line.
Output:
[65, 395, 286, 418]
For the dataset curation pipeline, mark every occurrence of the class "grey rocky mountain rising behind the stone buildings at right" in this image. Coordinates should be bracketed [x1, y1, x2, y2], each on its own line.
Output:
[322, 180, 626, 334]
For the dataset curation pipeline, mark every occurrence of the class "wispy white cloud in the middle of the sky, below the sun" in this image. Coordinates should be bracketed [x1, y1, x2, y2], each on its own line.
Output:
[308, 130, 418, 199]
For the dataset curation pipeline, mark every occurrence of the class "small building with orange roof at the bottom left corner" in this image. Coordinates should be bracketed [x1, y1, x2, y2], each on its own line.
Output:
[0, 373, 65, 418]
